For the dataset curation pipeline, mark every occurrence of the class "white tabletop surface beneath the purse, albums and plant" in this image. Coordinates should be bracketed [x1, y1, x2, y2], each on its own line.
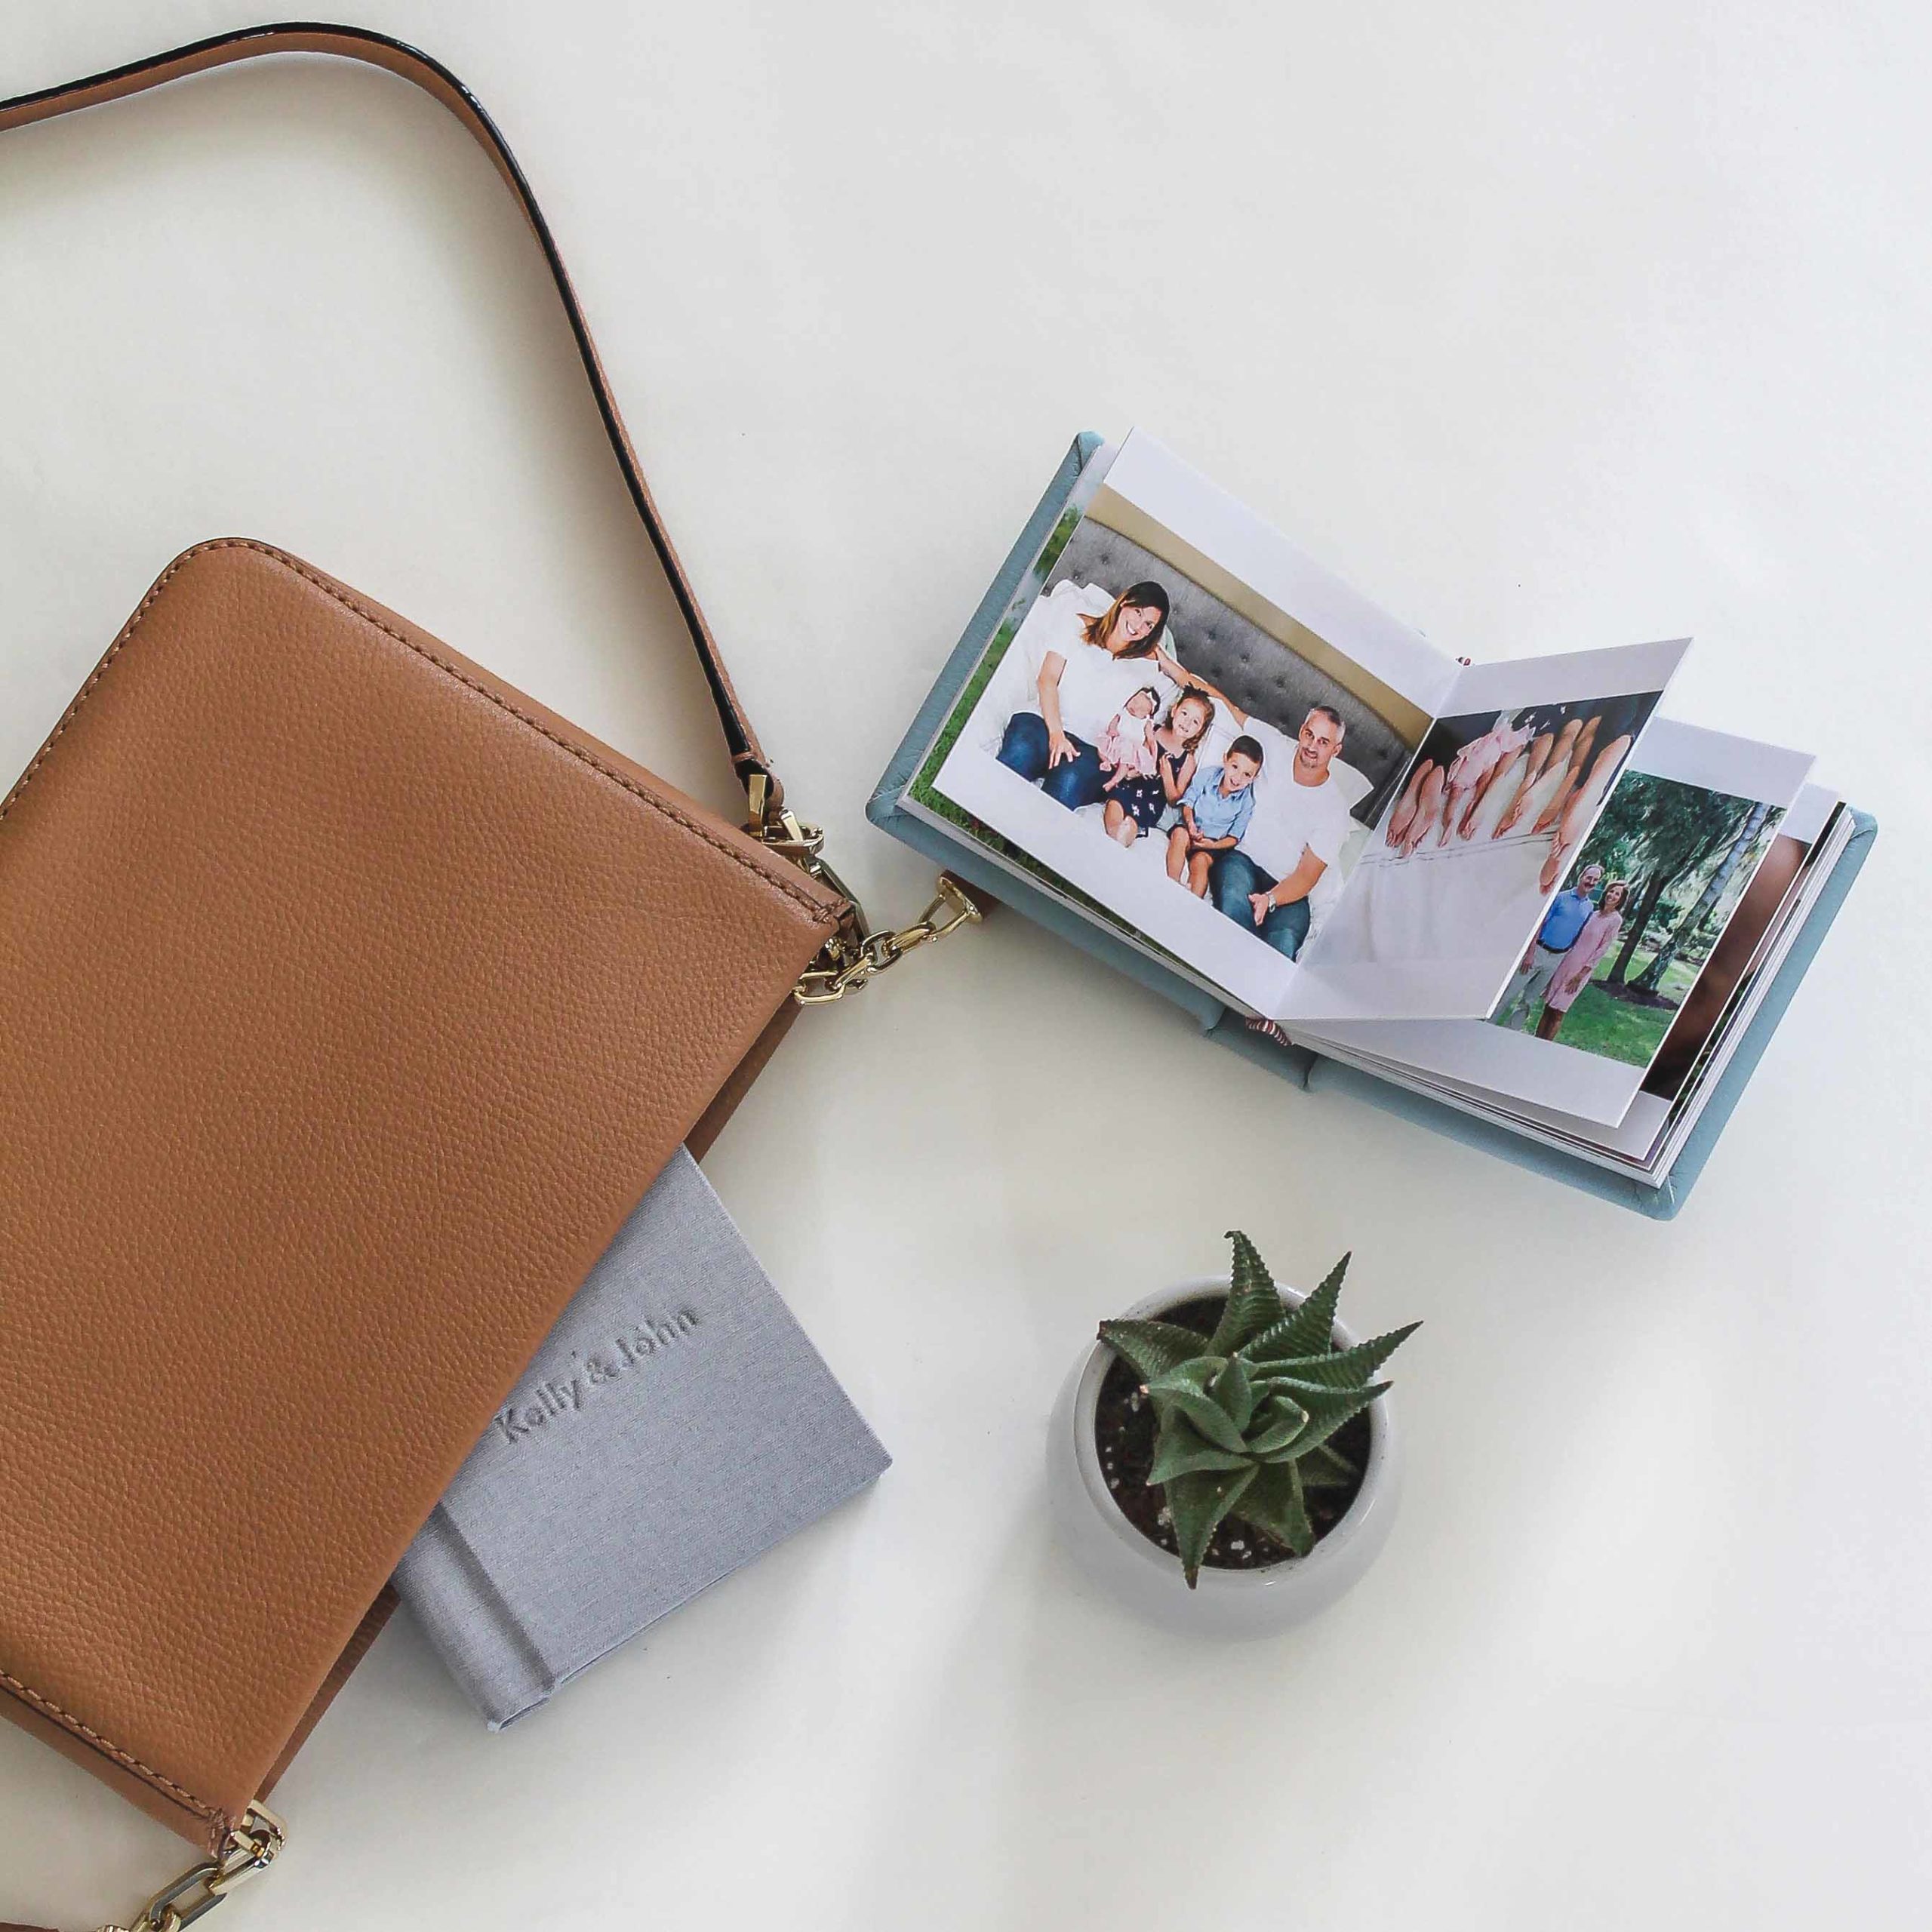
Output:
[0, 0, 1932, 1932]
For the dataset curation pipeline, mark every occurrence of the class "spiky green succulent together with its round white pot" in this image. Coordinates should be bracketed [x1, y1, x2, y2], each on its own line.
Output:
[1049, 1232, 1416, 1636]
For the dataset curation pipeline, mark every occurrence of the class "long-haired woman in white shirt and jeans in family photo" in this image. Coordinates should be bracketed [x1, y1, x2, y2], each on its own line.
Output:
[999, 583, 1180, 811]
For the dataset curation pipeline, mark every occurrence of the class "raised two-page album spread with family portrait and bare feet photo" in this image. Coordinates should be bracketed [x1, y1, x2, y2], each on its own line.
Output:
[904, 432, 1684, 1022]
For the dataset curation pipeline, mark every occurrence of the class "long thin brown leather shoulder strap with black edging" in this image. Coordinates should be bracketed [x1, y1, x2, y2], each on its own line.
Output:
[0, 21, 783, 815]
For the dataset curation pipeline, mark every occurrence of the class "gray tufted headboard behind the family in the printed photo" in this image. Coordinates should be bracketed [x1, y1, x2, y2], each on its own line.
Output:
[1048, 518, 1408, 825]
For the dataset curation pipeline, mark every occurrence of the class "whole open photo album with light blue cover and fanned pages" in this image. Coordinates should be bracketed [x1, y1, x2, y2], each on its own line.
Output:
[875, 431, 1855, 1184]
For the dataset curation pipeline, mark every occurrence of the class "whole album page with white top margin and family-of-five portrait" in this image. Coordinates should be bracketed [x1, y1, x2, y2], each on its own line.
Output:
[906, 431, 1459, 1014]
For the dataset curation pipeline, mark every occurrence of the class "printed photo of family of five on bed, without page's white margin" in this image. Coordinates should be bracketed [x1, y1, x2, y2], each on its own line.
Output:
[929, 442, 1429, 999]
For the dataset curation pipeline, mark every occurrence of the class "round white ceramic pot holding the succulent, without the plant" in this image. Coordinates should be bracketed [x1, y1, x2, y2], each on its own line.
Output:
[1048, 1275, 1398, 1640]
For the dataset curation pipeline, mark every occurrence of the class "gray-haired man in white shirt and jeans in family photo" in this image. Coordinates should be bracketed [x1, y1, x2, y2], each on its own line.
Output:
[1208, 705, 1349, 958]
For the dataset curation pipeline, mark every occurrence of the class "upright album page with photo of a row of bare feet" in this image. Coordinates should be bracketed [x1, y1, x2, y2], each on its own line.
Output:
[1277, 638, 1688, 1022]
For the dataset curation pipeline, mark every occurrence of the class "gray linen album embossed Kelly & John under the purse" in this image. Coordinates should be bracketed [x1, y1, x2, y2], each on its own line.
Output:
[396, 1148, 891, 1731]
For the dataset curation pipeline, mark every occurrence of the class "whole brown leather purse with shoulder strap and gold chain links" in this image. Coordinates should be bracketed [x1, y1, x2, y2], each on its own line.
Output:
[0, 25, 977, 1932]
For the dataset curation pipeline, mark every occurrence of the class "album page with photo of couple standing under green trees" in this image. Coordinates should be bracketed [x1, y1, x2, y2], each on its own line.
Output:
[1298, 718, 1824, 1128]
